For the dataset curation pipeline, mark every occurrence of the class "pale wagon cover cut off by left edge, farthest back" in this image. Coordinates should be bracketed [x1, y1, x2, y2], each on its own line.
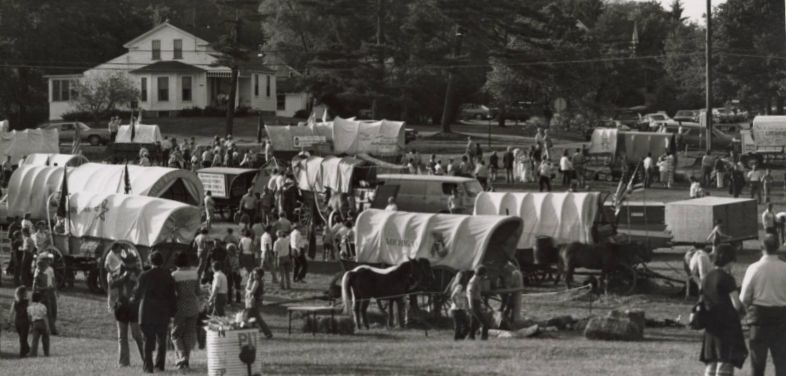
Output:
[0, 129, 60, 164]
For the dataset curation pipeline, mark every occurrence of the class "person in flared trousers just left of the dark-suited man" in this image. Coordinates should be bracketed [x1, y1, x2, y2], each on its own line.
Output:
[107, 251, 145, 367]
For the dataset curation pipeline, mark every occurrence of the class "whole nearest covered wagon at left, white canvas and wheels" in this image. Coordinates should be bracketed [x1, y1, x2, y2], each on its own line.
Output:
[53, 192, 201, 291]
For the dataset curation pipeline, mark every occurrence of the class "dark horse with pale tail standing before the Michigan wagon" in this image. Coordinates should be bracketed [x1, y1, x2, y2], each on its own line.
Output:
[341, 259, 433, 329]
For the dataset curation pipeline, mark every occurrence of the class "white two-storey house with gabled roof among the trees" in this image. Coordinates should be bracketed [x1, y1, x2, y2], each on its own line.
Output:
[46, 22, 278, 120]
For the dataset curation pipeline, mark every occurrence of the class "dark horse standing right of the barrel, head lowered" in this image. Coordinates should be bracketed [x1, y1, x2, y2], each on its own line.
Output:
[557, 238, 635, 293]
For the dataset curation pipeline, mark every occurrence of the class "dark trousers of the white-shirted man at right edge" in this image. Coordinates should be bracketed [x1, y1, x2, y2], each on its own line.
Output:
[749, 323, 786, 376]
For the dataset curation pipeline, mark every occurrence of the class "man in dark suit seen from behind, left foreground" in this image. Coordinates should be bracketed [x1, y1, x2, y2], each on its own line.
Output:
[134, 251, 177, 372]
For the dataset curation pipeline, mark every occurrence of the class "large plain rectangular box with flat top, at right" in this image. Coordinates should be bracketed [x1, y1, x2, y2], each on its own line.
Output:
[665, 197, 759, 243]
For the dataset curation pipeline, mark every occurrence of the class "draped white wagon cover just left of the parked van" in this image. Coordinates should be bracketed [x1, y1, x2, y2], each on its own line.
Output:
[292, 157, 369, 193]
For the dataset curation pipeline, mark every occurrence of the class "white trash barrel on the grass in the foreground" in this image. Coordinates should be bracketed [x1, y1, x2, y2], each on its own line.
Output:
[207, 329, 262, 376]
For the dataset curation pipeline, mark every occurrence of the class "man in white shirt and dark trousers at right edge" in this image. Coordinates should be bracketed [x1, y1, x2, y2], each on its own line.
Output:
[740, 234, 786, 376]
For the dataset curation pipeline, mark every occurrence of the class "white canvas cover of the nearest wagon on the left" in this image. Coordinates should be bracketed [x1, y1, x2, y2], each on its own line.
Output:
[68, 192, 200, 247]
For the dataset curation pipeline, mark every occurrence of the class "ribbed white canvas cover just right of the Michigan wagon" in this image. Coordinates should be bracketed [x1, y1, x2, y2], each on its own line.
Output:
[475, 192, 600, 249]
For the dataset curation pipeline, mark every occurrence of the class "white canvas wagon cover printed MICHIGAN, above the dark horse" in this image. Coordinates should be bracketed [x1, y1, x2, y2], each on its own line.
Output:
[355, 209, 521, 270]
